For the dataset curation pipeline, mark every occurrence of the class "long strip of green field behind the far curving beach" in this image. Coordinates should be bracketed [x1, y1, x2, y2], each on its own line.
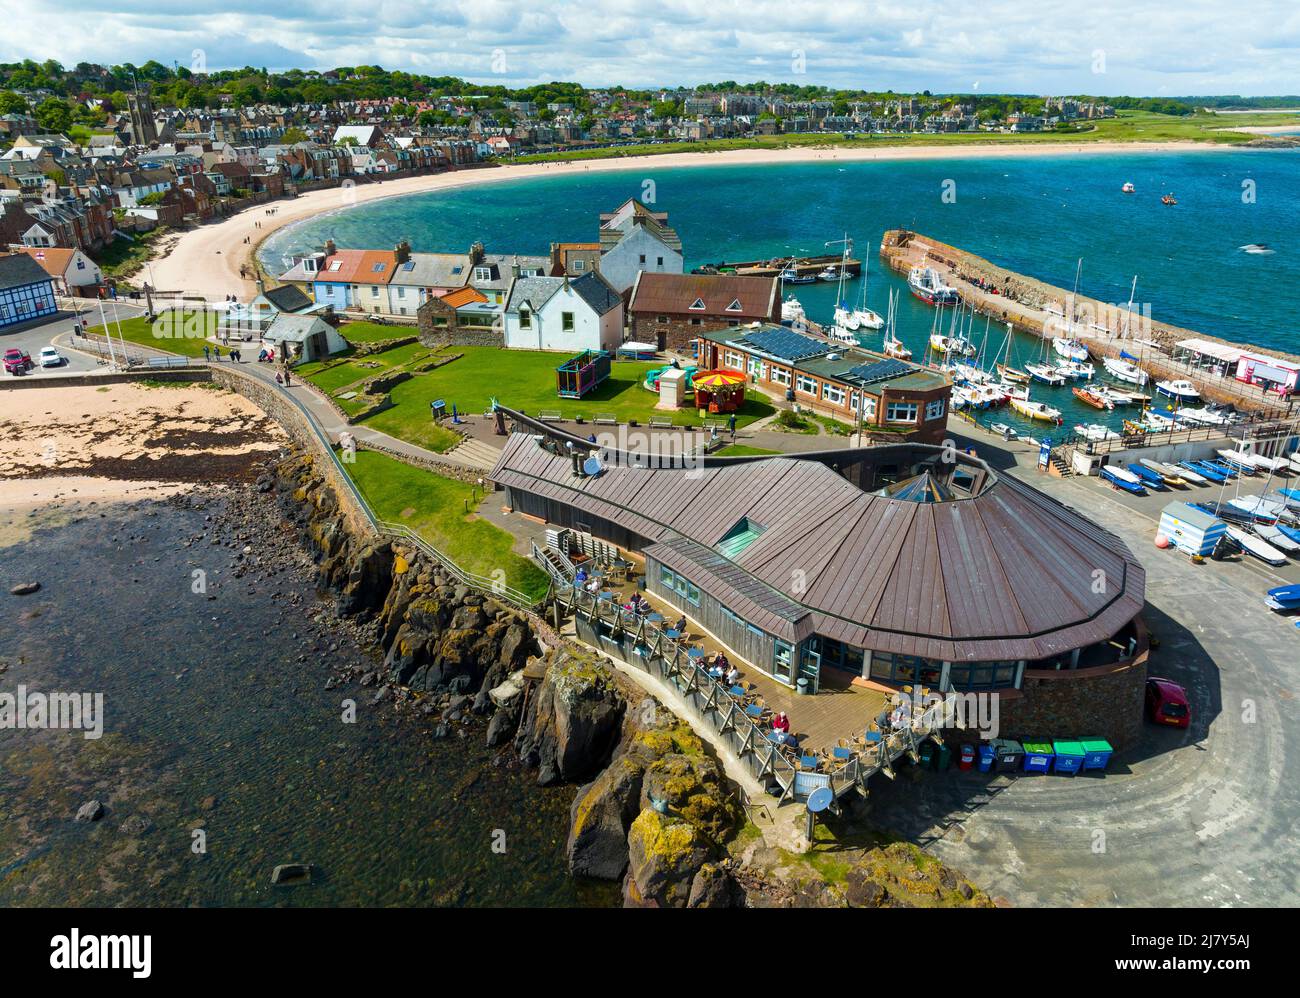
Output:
[510, 110, 1295, 162]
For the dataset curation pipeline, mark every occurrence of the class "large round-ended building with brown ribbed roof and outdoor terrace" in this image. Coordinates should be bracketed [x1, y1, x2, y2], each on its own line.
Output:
[489, 412, 1147, 747]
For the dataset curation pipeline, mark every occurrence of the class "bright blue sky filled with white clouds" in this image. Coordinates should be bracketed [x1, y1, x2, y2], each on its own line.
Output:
[0, 0, 1300, 96]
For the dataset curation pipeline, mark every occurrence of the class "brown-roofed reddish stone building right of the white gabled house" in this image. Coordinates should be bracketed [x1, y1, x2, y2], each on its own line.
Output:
[628, 272, 781, 351]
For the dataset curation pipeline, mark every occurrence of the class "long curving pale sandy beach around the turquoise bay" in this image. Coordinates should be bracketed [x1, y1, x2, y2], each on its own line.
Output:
[147, 142, 1242, 300]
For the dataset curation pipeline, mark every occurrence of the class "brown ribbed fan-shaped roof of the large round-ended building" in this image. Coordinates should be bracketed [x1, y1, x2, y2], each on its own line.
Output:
[490, 416, 1145, 661]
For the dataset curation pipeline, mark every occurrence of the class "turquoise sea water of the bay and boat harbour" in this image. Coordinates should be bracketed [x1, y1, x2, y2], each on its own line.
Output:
[263, 149, 1300, 436]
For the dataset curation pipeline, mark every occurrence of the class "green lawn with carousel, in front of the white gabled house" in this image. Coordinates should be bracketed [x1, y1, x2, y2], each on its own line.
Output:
[367, 347, 772, 443]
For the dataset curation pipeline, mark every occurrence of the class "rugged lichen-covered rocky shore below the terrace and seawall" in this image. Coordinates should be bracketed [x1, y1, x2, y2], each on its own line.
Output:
[266, 454, 991, 907]
